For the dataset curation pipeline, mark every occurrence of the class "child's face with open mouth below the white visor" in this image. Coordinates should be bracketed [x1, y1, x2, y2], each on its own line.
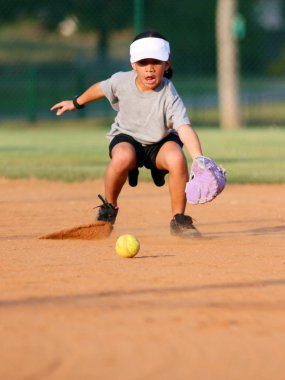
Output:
[132, 58, 170, 91]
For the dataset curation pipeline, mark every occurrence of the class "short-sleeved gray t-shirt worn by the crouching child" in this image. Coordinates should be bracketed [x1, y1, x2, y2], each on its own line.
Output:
[100, 71, 190, 145]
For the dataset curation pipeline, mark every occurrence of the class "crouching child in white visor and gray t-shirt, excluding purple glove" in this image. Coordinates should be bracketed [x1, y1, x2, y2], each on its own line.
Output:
[51, 32, 202, 236]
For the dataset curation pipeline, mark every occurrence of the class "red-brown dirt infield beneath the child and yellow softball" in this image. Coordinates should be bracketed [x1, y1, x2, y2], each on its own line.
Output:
[0, 179, 285, 380]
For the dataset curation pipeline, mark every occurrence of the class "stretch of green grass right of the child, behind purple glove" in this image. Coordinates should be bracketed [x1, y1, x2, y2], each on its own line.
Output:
[195, 128, 285, 183]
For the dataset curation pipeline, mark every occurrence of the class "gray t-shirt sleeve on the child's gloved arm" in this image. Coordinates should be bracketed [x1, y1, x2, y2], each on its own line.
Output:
[167, 83, 191, 130]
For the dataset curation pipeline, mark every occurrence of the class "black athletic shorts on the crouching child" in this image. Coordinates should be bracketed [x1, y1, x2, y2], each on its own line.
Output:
[109, 133, 183, 170]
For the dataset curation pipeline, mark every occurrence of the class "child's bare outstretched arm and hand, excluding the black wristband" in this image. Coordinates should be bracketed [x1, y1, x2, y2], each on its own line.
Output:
[50, 83, 105, 116]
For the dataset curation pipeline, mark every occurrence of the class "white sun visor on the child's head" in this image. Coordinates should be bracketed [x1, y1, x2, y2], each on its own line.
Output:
[130, 37, 170, 63]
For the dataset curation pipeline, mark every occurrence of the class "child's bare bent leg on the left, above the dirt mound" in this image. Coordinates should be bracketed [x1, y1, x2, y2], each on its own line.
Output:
[105, 142, 136, 207]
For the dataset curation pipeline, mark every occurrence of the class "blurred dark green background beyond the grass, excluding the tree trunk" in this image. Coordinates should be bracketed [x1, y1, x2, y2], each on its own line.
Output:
[0, 0, 285, 126]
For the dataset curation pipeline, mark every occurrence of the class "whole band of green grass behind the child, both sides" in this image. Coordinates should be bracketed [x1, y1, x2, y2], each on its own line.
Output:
[0, 120, 285, 183]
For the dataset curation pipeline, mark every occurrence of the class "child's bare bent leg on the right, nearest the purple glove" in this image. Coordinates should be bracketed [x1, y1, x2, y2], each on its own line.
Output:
[153, 141, 189, 216]
